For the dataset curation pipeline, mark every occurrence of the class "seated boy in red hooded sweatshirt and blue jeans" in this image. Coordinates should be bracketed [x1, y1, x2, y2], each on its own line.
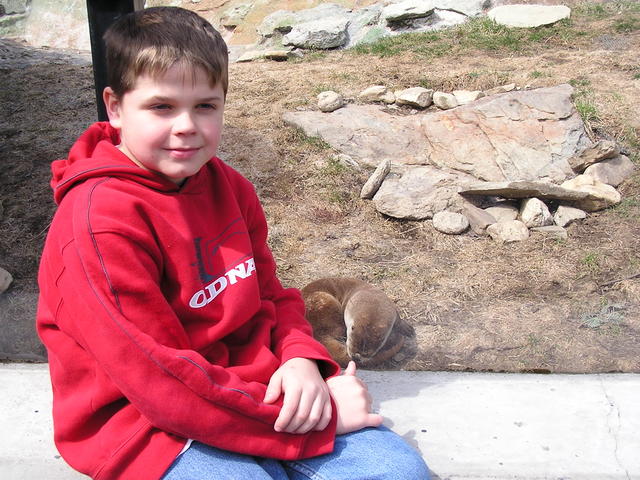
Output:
[37, 7, 428, 480]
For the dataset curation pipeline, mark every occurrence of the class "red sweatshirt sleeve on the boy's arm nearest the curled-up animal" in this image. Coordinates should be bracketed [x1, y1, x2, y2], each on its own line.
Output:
[239, 176, 340, 378]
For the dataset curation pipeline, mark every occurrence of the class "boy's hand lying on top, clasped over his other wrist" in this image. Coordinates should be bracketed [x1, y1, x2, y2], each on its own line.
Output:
[264, 358, 331, 433]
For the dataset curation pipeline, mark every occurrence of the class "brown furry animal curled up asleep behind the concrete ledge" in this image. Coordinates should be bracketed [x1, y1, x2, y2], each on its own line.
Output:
[302, 277, 413, 367]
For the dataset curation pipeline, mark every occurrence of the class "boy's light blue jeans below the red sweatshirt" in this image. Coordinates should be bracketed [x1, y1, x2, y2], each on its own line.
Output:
[162, 427, 430, 480]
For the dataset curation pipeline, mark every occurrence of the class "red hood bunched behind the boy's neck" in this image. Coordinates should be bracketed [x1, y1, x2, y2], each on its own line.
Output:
[51, 122, 180, 204]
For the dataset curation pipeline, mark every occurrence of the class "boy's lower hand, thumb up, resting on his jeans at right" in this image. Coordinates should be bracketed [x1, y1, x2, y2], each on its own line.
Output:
[327, 362, 382, 435]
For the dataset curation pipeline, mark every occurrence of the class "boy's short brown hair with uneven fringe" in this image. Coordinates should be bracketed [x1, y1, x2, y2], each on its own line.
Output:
[103, 7, 229, 97]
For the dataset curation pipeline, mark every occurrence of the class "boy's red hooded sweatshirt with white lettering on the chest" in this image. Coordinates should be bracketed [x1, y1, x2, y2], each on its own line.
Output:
[37, 123, 339, 480]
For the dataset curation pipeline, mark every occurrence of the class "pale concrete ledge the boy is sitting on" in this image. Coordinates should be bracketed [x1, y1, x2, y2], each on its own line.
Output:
[0, 364, 640, 480]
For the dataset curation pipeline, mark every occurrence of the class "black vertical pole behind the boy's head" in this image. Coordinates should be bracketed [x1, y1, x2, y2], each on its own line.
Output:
[87, 0, 144, 121]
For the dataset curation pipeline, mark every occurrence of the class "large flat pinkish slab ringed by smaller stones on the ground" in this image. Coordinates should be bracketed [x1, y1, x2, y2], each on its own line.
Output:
[284, 85, 634, 242]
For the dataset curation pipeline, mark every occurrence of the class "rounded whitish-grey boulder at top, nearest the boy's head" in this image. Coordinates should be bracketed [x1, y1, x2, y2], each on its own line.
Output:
[282, 18, 349, 50]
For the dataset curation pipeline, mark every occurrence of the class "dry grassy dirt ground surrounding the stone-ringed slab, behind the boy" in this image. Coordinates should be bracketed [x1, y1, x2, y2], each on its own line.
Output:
[0, 2, 640, 372]
